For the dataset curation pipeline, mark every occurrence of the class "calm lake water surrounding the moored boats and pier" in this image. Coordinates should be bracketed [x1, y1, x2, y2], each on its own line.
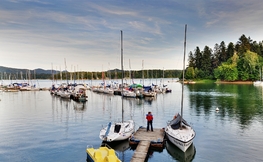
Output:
[0, 79, 263, 162]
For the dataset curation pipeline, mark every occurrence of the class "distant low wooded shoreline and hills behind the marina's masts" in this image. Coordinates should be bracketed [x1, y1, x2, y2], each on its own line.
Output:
[0, 66, 182, 80]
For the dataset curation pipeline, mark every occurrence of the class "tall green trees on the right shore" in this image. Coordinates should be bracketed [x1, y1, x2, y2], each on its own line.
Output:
[185, 34, 263, 81]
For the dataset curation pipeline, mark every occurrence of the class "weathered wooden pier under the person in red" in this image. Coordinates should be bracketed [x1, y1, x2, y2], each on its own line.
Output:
[129, 127, 165, 162]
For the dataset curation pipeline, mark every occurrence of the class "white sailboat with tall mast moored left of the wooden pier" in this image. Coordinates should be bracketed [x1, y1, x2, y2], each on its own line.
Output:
[99, 31, 135, 142]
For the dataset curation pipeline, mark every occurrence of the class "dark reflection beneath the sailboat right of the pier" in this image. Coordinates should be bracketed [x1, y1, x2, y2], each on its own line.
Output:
[166, 141, 196, 162]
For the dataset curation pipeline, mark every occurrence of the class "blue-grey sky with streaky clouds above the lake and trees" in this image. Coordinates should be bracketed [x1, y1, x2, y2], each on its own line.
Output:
[0, 0, 263, 72]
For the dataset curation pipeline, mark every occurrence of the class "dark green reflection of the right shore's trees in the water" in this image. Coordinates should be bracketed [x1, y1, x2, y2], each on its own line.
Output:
[187, 84, 263, 128]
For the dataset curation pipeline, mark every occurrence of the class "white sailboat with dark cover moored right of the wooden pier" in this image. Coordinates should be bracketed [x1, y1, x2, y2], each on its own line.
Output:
[165, 25, 195, 152]
